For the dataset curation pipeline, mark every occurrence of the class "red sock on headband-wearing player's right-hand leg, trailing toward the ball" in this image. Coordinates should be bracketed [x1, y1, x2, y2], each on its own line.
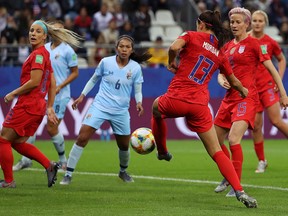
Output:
[12, 143, 50, 169]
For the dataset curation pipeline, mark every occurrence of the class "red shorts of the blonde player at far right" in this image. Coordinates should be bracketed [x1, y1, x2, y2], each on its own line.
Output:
[256, 88, 279, 112]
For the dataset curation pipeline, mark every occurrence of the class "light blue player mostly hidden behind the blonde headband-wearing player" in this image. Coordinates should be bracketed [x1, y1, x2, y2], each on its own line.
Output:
[13, 20, 78, 171]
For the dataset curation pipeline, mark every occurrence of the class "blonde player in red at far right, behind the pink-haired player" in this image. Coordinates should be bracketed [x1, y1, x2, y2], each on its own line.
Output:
[249, 10, 288, 173]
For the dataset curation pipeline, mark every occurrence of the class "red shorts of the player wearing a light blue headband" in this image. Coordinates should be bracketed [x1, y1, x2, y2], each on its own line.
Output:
[3, 104, 44, 137]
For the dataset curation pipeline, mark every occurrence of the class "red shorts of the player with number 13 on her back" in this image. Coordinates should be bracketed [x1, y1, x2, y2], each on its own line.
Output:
[158, 95, 213, 133]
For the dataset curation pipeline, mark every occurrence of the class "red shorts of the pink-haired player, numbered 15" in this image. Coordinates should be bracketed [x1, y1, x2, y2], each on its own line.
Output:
[214, 98, 258, 129]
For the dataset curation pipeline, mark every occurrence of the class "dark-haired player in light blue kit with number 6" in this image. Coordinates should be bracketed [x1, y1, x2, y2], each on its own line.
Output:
[60, 35, 151, 185]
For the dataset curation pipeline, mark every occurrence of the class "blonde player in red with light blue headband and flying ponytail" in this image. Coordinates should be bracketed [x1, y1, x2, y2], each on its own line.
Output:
[0, 20, 79, 188]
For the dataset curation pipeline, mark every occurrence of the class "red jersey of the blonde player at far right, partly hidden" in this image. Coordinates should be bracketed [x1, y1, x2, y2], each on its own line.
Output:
[252, 35, 282, 92]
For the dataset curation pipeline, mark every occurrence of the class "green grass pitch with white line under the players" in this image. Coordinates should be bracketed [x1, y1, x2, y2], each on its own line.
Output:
[0, 140, 288, 216]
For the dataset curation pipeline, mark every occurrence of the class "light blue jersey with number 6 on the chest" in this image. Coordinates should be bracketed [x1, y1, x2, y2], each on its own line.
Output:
[93, 55, 143, 114]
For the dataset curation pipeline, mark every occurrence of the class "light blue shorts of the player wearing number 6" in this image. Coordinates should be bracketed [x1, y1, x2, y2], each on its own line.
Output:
[82, 103, 131, 135]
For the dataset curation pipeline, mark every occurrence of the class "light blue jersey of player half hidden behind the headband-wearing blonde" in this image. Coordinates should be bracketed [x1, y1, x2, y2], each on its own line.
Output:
[45, 42, 78, 102]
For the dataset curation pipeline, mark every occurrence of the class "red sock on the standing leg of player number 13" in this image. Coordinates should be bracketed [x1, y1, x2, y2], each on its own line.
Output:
[212, 151, 243, 191]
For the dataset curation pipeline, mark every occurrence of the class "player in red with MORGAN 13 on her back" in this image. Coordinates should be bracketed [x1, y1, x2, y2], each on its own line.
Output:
[151, 11, 257, 208]
